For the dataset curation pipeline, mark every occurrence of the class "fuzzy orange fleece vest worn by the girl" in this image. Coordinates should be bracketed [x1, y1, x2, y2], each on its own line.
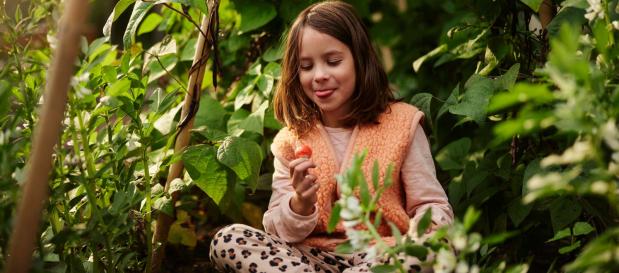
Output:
[272, 103, 423, 250]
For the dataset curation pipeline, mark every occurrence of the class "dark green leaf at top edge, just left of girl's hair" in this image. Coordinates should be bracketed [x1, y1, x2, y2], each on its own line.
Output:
[234, 0, 277, 32]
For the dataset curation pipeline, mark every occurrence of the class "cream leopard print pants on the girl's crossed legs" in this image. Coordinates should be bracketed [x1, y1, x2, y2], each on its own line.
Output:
[210, 224, 432, 273]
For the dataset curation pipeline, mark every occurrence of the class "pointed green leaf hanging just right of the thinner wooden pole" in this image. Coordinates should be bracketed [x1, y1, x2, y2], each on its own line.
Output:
[182, 145, 228, 204]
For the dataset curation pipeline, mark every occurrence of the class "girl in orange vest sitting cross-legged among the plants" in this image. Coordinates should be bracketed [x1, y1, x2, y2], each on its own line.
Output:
[210, 2, 453, 272]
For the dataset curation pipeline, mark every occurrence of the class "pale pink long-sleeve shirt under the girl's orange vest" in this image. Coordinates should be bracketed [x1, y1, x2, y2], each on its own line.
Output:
[263, 121, 453, 243]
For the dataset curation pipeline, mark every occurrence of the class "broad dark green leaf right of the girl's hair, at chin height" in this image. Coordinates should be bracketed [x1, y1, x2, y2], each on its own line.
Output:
[449, 74, 496, 125]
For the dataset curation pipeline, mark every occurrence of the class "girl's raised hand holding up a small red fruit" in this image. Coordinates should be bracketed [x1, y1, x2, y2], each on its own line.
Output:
[288, 157, 319, 215]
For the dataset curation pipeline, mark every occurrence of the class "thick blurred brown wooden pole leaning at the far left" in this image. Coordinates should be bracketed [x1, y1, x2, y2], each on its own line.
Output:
[6, 0, 89, 273]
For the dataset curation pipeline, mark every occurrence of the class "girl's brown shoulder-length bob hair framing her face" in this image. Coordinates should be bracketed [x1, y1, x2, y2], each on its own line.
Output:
[273, 1, 395, 136]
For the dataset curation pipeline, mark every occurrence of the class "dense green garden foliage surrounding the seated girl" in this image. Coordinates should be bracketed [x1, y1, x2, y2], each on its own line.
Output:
[0, 0, 619, 272]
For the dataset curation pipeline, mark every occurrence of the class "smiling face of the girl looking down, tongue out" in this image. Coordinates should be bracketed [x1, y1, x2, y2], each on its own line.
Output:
[299, 27, 356, 127]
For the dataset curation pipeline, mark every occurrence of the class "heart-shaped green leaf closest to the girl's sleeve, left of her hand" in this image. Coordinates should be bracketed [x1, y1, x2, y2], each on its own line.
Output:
[217, 136, 264, 189]
